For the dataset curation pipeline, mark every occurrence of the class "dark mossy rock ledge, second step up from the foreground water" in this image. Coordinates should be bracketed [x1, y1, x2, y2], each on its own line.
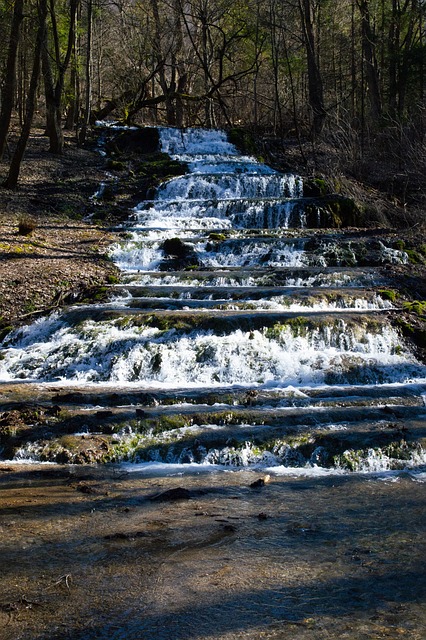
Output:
[1, 396, 426, 440]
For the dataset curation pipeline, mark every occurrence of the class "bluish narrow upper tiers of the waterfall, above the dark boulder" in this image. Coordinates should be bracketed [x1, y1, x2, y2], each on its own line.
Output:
[131, 129, 303, 229]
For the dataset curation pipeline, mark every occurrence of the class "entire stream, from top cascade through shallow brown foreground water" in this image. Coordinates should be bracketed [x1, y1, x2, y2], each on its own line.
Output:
[0, 128, 426, 640]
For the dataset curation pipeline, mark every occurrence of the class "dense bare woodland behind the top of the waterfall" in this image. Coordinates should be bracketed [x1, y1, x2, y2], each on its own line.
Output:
[0, 0, 426, 215]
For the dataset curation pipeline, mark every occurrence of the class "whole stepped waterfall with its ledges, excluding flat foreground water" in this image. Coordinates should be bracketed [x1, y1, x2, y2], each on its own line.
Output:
[0, 128, 426, 473]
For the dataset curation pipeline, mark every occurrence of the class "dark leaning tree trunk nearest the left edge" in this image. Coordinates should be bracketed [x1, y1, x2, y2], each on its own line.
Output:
[0, 0, 24, 160]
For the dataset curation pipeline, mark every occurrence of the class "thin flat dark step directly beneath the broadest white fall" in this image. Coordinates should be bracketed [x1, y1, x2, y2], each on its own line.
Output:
[0, 382, 426, 411]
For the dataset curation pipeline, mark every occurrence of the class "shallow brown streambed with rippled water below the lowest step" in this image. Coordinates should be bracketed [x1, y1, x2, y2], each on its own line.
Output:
[0, 465, 426, 640]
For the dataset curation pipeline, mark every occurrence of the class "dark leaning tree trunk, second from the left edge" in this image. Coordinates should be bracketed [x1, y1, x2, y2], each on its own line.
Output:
[3, 0, 47, 189]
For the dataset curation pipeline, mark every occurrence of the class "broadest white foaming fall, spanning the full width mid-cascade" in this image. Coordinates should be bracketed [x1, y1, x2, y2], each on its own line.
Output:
[0, 318, 426, 387]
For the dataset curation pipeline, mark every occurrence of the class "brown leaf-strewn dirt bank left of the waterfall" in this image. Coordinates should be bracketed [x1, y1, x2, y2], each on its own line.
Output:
[0, 131, 117, 329]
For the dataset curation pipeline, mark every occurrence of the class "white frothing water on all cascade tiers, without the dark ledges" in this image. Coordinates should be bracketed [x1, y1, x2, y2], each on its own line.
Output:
[0, 129, 426, 474]
